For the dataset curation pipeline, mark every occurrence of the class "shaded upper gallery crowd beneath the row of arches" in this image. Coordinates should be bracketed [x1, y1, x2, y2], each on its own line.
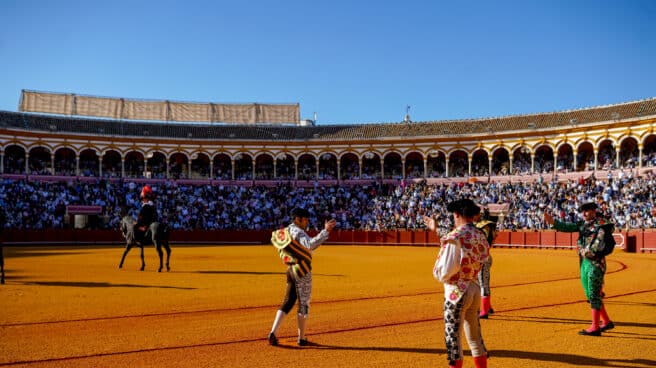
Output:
[3, 144, 644, 180]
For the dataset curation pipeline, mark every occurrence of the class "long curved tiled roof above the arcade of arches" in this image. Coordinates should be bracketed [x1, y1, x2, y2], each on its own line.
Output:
[0, 98, 656, 142]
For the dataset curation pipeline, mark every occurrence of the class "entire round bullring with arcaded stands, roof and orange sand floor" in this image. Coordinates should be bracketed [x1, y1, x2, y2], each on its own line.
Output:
[0, 91, 656, 368]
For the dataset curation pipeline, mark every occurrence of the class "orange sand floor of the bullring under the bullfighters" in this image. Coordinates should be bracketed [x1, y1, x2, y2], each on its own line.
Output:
[0, 246, 656, 368]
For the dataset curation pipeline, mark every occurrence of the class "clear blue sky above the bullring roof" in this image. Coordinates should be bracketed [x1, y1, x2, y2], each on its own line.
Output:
[0, 0, 656, 125]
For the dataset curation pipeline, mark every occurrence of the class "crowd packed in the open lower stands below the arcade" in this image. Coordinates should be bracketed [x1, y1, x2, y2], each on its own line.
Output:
[0, 170, 656, 236]
